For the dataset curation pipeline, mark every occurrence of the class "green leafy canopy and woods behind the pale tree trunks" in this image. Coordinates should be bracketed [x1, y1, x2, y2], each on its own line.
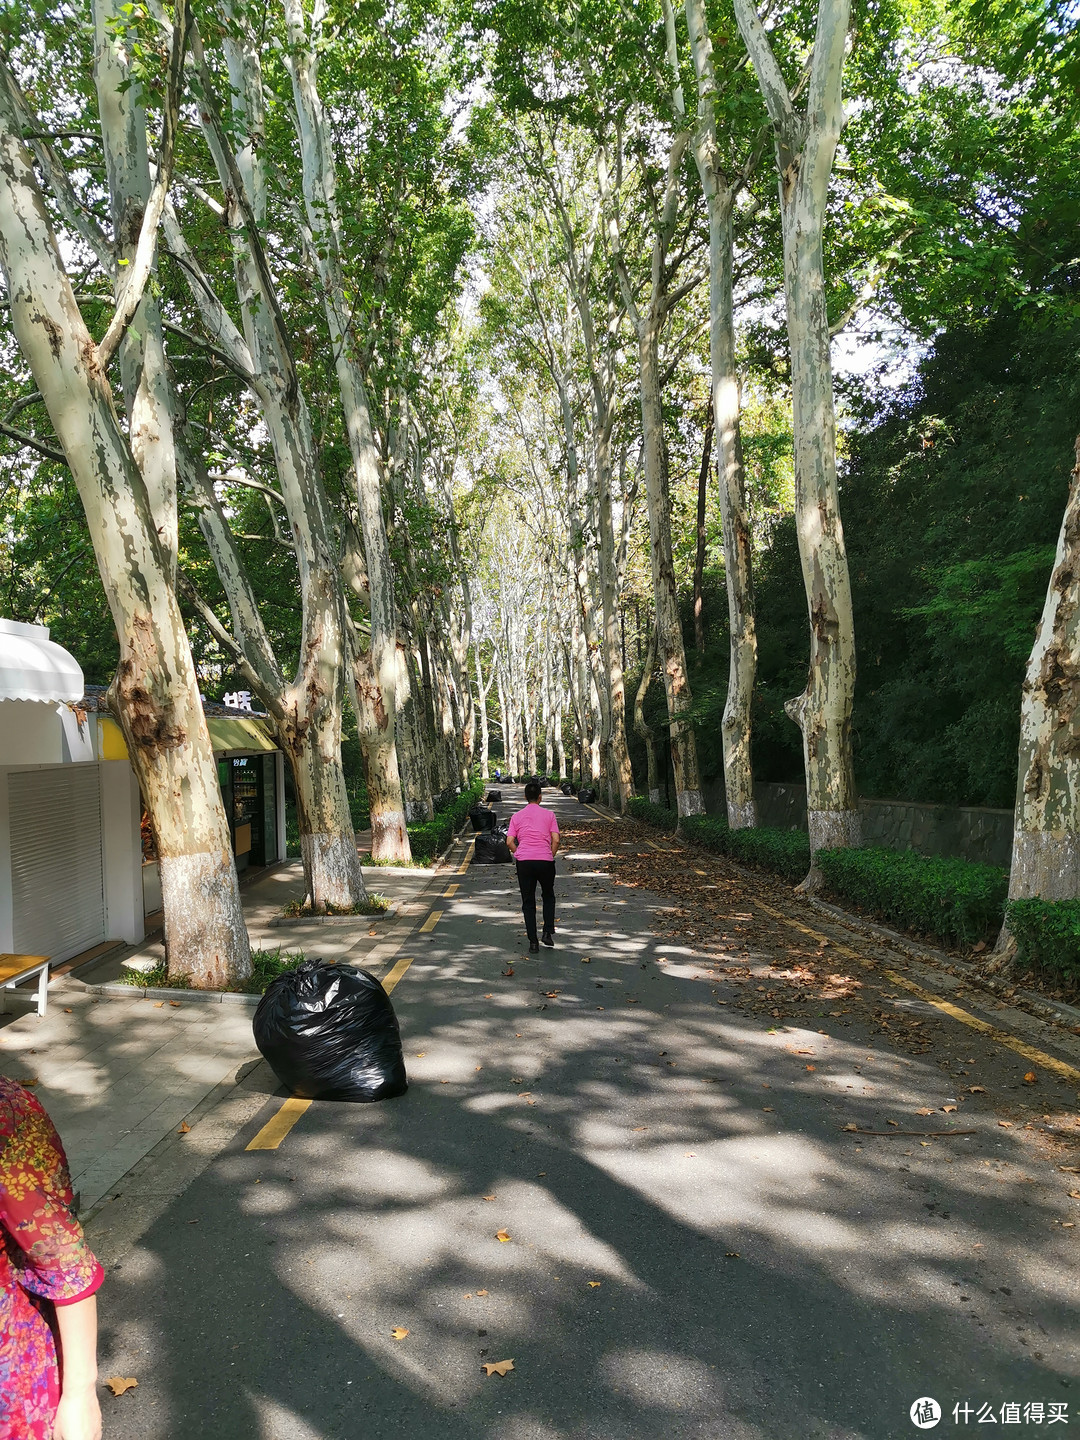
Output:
[0, 0, 1080, 967]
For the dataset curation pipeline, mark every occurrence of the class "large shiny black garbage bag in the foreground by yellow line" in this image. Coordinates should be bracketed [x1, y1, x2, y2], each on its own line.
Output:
[252, 959, 409, 1104]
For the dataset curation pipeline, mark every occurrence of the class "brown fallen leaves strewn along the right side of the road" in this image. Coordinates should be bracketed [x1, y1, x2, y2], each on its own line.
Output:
[563, 821, 1080, 1158]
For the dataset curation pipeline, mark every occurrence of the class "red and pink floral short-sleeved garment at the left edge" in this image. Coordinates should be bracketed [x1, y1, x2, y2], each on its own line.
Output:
[0, 1076, 104, 1440]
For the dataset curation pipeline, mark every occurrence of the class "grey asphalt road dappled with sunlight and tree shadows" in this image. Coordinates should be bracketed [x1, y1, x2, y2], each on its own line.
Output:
[92, 792, 1080, 1440]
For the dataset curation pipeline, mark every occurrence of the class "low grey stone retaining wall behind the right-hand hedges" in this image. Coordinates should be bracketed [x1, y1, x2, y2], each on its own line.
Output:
[704, 780, 1012, 868]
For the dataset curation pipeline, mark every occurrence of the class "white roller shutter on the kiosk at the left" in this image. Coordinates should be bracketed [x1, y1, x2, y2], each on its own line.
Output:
[7, 765, 105, 960]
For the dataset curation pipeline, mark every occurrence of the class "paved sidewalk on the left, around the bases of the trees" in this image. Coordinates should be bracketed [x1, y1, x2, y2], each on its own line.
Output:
[0, 840, 467, 1214]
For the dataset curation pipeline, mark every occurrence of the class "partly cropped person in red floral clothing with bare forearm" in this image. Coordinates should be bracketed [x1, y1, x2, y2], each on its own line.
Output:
[0, 1076, 105, 1440]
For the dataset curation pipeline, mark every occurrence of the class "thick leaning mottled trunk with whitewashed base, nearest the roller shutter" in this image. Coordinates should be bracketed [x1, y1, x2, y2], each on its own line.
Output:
[0, 101, 251, 988]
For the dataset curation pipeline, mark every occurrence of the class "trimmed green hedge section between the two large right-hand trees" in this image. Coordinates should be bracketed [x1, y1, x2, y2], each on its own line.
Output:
[816, 850, 1008, 945]
